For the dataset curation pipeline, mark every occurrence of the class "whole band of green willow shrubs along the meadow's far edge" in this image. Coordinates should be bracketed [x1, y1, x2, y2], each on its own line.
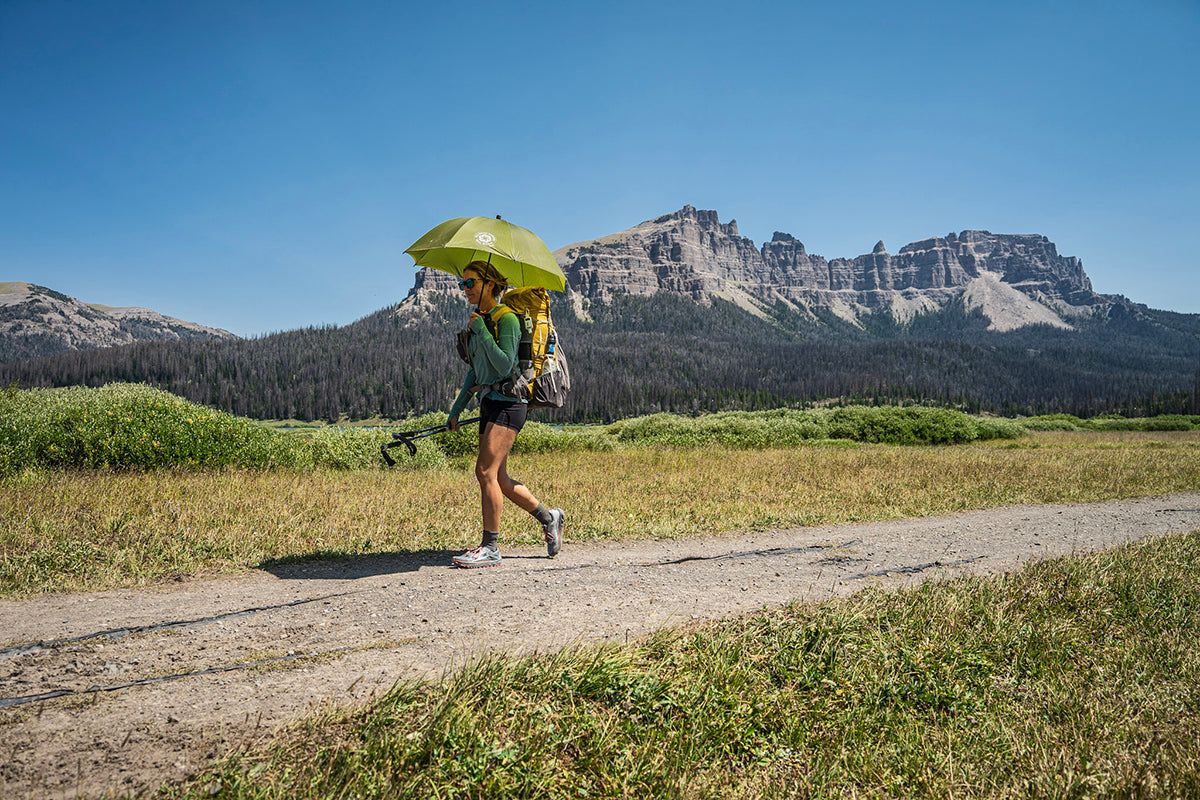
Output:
[21, 384, 1200, 475]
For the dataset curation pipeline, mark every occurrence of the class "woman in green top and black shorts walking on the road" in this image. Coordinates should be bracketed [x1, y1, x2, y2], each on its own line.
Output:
[446, 261, 565, 569]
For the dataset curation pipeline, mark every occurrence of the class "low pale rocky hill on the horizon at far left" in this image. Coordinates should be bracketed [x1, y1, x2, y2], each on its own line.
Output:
[0, 282, 236, 363]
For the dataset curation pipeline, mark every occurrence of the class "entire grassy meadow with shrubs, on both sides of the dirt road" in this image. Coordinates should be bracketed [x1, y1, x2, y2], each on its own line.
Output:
[7, 386, 1200, 798]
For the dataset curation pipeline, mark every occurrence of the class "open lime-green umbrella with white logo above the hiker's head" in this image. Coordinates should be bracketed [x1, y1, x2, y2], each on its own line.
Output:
[404, 216, 566, 291]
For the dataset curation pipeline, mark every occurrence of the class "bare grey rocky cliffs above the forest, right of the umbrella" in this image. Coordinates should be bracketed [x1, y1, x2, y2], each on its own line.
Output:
[554, 205, 1112, 330]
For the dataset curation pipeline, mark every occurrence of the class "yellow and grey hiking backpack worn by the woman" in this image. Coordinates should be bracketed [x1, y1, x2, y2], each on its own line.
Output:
[458, 287, 571, 408]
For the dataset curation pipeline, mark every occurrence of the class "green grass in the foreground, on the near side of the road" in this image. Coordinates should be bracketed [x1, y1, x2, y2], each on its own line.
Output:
[162, 533, 1200, 799]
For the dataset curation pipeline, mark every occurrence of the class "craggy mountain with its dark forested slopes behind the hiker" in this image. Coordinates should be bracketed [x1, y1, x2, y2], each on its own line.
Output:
[0, 205, 1200, 421]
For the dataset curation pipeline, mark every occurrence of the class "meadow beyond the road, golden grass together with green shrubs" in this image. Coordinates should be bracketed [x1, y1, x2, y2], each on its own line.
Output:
[0, 385, 1200, 596]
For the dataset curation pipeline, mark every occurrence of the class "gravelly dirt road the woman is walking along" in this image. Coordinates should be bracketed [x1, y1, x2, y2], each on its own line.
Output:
[0, 492, 1200, 798]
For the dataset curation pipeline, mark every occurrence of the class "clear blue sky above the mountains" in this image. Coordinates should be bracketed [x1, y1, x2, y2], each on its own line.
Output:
[0, 0, 1200, 336]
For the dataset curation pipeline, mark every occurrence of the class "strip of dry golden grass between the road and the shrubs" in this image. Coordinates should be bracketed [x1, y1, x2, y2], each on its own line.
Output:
[0, 432, 1200, 596]
